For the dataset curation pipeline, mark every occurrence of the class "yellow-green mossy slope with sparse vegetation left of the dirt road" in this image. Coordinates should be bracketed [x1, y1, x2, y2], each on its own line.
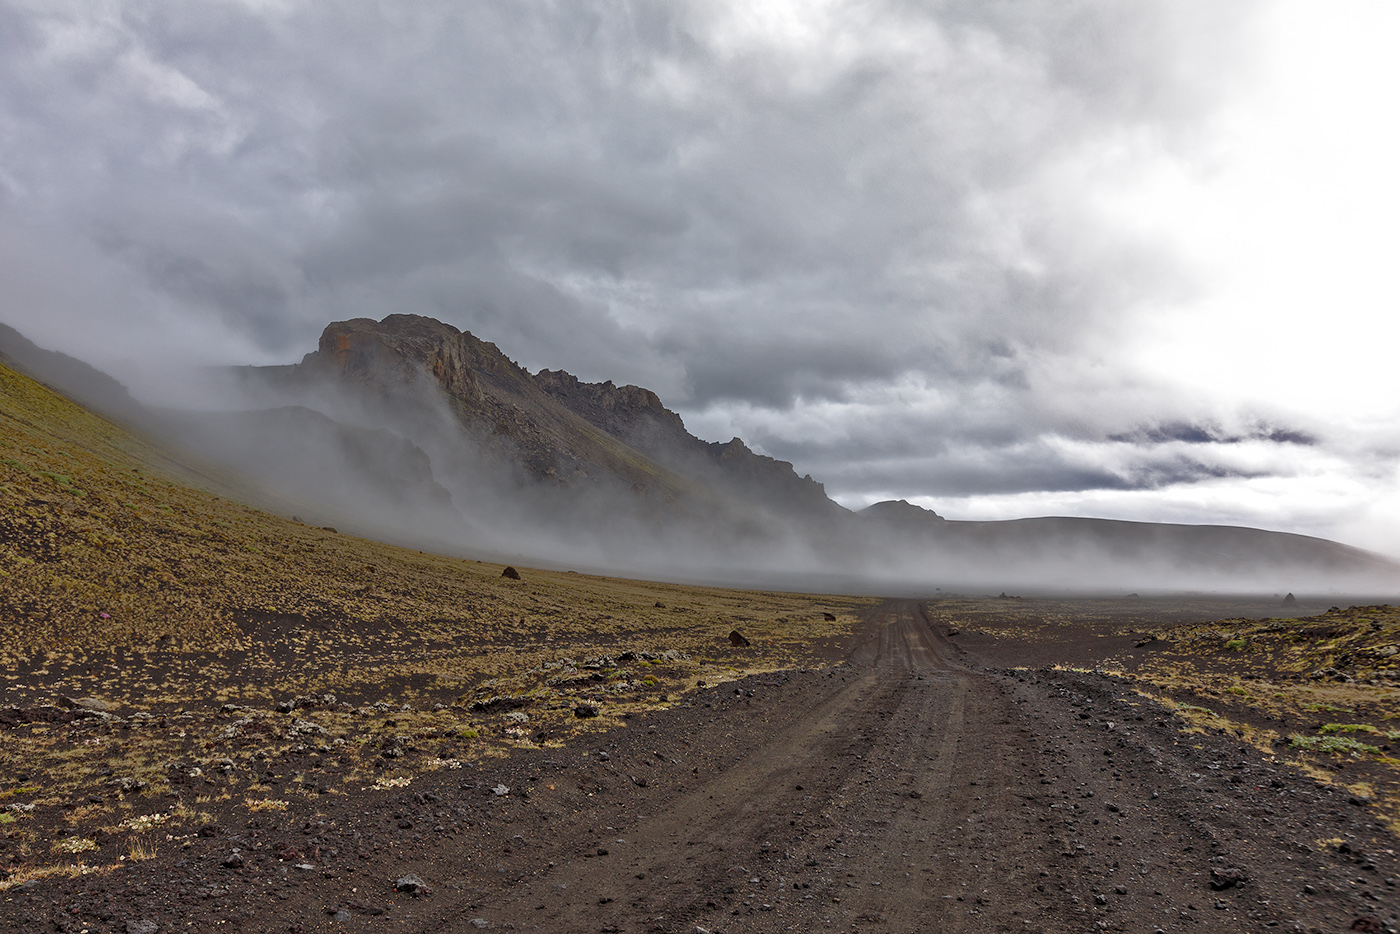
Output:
[0, 367, 874, 886]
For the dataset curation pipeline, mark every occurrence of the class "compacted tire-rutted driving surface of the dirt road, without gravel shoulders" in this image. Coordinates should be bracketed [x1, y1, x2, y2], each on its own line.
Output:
[453, 602, 1089, 931]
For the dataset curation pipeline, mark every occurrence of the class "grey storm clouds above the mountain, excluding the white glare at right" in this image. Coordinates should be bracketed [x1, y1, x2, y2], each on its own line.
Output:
[19, 0, 1377, 537]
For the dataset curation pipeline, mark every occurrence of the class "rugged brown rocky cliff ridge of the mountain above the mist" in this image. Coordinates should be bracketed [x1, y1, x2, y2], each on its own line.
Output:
[244, 315, 844, 520]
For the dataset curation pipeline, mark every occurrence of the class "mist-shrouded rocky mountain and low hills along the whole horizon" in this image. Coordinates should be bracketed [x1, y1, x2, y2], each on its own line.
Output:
[4, 315, 1400, 595]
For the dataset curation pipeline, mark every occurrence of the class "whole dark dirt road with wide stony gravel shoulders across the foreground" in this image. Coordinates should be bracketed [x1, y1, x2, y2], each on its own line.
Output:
[0, 602, 1400, 934]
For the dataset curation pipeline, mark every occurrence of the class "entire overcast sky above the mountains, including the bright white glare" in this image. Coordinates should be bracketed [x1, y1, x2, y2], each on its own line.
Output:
[8, 0, 1400, 553]
